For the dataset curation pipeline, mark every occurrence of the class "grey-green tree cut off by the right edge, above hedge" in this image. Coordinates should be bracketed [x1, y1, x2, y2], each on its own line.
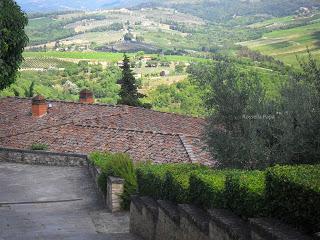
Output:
[275, 53, 320, 163]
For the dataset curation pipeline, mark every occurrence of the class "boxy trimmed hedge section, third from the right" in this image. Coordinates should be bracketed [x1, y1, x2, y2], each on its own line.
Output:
[189, 170, 232, 209]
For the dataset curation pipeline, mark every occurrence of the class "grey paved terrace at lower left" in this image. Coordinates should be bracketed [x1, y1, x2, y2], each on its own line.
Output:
[0, 163, 137, 240]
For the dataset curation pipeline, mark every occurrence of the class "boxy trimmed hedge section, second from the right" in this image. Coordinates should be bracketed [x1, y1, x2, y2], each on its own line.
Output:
[225, 171, 266, 217]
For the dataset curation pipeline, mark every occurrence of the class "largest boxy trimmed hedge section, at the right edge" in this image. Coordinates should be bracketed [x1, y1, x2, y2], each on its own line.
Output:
[266, 165, 320, 232]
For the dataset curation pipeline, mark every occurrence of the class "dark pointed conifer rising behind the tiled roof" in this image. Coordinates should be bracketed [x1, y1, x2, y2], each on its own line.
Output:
[118, 55, 144, 107]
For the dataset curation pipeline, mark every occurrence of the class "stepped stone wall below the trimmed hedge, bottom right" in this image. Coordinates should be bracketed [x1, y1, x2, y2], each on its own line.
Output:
[130, 196, 312, 240]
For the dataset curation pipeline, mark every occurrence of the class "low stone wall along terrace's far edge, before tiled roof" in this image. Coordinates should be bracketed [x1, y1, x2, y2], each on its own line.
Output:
[0, 147, 87, 166]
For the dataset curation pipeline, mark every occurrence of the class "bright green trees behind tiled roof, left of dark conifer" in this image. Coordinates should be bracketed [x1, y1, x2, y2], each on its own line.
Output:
[0, 61, 121, 104]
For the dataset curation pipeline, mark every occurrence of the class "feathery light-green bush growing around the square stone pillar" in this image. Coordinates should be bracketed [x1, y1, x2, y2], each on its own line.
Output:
[89, 152, 137, 209]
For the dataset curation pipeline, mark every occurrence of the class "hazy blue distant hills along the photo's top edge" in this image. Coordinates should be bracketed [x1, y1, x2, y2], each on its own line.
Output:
[17, 0, 320, 21]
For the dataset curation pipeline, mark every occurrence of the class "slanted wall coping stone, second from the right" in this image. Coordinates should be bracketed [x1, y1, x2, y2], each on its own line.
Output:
[208, 209, 251, 240]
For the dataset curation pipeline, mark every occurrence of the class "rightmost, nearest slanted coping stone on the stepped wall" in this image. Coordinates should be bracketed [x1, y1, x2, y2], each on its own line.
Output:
[249, 218, 312, 240]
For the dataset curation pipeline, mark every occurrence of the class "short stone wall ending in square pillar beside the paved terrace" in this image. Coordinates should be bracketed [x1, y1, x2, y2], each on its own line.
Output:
[88, 161, 124, 212]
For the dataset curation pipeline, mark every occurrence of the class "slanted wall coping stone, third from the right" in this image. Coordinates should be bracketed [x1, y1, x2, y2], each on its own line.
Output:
[178, 204, 210, 235]
